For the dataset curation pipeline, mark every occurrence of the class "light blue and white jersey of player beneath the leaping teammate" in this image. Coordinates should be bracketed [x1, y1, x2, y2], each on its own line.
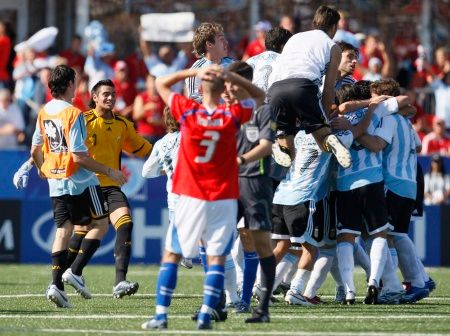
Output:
[273, 131, 332, 205]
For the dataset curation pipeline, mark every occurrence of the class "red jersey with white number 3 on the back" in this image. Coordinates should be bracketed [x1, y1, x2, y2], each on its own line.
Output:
[170, 93, 255, 201]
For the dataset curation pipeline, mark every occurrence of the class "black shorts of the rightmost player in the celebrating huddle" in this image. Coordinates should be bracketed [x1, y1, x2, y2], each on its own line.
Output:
[386, 190, 416, 236]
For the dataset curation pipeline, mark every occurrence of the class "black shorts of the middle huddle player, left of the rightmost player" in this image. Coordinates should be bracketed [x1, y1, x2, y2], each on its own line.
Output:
[336, 181, 391, 235]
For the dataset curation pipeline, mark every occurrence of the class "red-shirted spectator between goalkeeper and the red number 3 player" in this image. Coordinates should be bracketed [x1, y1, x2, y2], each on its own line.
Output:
[133, 75, 165, 144]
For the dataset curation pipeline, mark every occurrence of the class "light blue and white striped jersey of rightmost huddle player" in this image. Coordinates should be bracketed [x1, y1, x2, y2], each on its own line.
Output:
[374, 114, 420, 199]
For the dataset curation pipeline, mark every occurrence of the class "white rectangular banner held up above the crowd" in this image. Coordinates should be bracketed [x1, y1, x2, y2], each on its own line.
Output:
[141, 12, 195, 42]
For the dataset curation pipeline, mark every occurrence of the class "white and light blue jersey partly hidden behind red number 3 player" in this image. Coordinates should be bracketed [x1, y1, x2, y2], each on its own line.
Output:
[142, 132, 181, 210]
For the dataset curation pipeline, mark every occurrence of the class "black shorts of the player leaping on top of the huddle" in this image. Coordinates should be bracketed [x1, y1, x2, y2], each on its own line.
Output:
[267, 78, 326, 135]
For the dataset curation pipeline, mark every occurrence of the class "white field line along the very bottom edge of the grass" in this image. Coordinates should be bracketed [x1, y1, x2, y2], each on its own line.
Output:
[0, 328, 443, 336]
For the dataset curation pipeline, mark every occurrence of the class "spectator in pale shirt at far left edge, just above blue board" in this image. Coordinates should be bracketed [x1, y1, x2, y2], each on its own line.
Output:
[0, 89, 25, 149]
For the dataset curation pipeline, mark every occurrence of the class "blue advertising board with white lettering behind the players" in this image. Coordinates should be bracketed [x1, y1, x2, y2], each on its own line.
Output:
[0, 151, 450, 266]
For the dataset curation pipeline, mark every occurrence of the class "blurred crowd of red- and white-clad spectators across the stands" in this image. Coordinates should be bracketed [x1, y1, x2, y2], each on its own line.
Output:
[0, 12, 450, 203]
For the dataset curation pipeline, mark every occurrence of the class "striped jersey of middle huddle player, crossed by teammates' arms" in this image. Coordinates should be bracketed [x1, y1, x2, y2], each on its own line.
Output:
[336, 98, 398, 191]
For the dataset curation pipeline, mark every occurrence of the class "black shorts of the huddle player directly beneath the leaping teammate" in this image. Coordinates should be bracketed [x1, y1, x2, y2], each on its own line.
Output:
[272, 200, 325, 246]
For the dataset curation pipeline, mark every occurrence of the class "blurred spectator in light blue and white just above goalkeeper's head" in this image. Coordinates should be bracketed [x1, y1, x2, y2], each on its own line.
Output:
[84, 42, 114, 90]
